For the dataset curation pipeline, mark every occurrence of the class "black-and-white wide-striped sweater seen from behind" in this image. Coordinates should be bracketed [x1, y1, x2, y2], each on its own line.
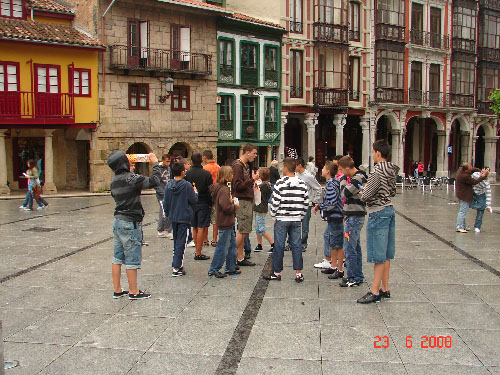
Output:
[270, 176, 309, 221]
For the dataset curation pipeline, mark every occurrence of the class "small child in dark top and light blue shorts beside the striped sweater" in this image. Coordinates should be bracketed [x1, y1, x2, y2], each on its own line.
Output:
[253, 168, 274, 253]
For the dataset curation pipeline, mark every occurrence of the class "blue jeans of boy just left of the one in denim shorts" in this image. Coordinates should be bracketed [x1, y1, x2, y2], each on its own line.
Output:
[344, 216, 365, 282]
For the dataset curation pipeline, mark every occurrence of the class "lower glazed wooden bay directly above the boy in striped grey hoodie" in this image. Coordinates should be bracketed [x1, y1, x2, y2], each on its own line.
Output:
[375, 48, 404, 89]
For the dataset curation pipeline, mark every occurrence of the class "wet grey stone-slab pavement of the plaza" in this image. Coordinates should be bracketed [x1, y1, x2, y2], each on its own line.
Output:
[0, 186, 500, 375]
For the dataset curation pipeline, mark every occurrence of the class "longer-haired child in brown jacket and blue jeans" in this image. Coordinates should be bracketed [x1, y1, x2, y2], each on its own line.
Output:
[208, 167, 241, 278]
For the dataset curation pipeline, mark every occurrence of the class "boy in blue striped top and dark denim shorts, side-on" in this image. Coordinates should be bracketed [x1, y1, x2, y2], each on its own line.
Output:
[314, 161, 344, 280]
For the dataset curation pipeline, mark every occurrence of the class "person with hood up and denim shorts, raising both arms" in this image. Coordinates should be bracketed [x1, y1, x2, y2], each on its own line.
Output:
[107, 151, 160, 299]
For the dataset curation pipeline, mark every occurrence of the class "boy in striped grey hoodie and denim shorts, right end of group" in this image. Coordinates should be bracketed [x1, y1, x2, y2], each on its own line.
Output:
[358, 139, 399, 303]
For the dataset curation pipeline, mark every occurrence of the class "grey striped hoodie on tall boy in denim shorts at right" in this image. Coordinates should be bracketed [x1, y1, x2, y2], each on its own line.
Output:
[361, 161, 399, 213]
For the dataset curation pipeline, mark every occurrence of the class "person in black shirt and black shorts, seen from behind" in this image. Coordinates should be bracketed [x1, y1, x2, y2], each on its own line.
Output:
[186, 152, 213, 260]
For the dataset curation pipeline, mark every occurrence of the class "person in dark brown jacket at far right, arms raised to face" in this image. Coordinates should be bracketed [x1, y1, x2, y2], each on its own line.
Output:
[455, 163, 488, 233]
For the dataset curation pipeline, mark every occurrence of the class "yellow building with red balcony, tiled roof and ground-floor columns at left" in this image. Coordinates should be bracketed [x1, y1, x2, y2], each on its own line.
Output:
[0, 0, 104, 194]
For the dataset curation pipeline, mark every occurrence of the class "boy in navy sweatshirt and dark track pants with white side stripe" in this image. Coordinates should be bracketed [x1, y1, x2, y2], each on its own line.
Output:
[163, 163, 198, 277]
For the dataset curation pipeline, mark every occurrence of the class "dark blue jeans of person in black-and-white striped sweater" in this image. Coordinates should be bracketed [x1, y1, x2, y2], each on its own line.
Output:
[273, 220, 303, 272]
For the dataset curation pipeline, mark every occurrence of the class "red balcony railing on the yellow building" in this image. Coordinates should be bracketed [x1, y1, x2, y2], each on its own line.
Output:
[0, 91, 75, 124]
